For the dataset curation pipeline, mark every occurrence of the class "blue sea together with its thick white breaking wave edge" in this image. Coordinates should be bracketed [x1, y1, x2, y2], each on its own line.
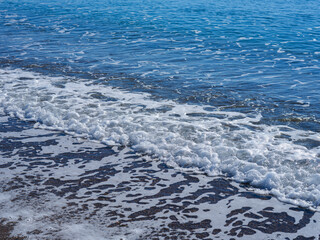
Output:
[0, 0, 320, 206]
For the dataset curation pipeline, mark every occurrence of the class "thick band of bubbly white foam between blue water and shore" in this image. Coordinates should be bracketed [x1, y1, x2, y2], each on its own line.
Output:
[0, 69, 320, 207]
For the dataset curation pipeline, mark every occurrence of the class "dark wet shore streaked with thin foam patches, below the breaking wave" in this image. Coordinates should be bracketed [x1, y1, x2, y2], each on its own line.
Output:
[0, 116, 320, 239]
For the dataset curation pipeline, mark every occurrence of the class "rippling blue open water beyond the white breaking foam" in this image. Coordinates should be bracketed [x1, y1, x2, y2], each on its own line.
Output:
[0, 0, 320, 131]
